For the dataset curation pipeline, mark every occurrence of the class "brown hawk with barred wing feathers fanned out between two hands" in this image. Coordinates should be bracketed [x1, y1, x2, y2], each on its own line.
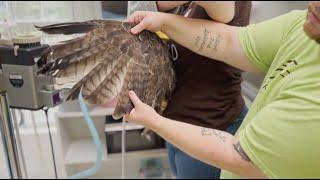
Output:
[36, 20, 176, 119]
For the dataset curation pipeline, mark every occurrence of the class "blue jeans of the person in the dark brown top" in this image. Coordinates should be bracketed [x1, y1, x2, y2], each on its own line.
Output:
[166, 107, 248, 179]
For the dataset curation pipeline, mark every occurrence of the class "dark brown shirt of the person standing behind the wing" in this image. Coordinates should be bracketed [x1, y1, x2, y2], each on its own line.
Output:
[164, 1, 251, 129]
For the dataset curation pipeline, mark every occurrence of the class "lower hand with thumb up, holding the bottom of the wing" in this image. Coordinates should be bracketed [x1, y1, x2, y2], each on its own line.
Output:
[124, 91, 160, 128]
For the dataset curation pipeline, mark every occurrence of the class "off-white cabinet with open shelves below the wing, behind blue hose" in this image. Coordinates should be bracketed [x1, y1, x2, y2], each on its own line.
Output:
[54, 102, 170, 178]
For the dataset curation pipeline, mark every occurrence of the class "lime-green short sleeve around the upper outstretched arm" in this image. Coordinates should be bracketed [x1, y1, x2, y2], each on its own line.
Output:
[238, 11, 296, 73]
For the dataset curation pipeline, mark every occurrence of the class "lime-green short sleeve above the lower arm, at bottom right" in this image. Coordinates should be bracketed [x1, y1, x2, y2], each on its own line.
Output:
[239, 83, 320, 178]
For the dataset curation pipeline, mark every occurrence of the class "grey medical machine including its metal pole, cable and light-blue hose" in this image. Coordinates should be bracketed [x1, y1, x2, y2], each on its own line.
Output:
[0, 36, 109, 179]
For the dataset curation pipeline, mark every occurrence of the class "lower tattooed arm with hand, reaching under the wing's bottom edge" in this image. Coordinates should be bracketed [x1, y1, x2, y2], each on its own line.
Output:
[125, 92, 264, 178]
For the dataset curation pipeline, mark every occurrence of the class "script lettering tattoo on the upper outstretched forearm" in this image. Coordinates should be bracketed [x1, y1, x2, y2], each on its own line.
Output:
[194, 28, 221, 51]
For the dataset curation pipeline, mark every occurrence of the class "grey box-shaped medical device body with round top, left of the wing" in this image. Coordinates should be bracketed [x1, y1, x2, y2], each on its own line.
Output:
[0, 37, 62, 110]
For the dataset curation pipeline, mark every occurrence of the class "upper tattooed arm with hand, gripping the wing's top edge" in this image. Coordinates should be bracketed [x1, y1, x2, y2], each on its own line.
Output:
[127, 11, 261, 73]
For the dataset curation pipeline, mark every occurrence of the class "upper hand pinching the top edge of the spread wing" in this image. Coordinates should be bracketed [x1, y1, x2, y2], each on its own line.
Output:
[127, 11, 166, 34]
